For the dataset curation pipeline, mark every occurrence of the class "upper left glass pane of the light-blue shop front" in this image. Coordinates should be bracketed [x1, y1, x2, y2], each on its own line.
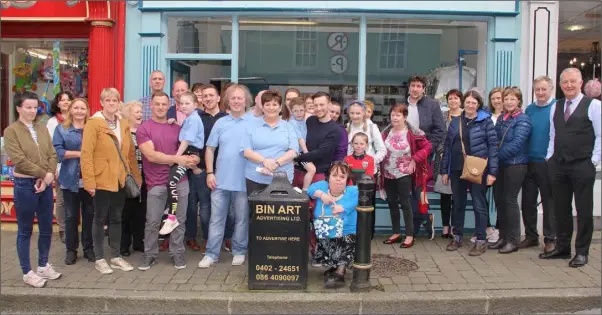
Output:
[167, 16, 232, 54]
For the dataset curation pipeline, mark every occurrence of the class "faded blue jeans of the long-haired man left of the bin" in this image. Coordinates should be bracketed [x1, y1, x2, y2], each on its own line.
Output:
[205, 188, 249, 260]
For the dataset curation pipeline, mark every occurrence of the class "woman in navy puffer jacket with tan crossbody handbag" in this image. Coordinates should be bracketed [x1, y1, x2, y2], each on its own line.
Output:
[439, 91, 498, 256]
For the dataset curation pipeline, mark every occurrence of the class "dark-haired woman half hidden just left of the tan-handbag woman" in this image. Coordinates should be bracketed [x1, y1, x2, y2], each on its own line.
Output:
[433, 89, 464, 238]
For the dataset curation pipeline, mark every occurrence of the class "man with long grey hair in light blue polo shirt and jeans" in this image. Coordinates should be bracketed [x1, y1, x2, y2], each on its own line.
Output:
[199, 84, 250, 268]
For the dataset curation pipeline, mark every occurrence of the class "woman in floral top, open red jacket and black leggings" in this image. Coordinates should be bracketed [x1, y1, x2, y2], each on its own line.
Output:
[379, 104, 432, 248]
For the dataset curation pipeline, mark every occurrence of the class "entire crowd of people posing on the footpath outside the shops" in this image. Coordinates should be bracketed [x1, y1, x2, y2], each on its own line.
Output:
[5, 68, 602, 288]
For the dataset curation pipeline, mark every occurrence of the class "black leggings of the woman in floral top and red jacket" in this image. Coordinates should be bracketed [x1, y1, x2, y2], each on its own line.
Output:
[385, 176, 414, 236]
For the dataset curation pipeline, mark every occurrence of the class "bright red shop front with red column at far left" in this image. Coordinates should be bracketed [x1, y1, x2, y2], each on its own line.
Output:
[0, 1, 125, 222]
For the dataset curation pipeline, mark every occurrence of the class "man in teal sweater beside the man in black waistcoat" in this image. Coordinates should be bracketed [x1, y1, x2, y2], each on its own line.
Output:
[519, 76, 556, 252]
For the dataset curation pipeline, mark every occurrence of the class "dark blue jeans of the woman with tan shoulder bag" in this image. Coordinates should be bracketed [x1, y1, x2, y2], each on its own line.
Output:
[450, 171, 489, 241]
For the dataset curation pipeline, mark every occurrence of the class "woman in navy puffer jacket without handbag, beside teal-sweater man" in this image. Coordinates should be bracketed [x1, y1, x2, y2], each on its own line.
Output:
[489, 87, 531, 254]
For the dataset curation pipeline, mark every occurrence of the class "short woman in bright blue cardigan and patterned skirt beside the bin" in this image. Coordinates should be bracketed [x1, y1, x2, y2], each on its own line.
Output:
[307, 162, 359, 288]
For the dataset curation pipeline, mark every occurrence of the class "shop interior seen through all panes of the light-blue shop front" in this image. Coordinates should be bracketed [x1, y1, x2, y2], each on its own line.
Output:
[167, 17, 487, 126]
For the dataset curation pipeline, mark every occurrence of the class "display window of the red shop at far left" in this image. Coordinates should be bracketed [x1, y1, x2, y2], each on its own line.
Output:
[0, 39, 88, 130]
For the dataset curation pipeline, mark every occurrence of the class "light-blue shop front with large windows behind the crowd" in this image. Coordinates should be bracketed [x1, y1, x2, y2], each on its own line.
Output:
[125, 1, 520, 232]
